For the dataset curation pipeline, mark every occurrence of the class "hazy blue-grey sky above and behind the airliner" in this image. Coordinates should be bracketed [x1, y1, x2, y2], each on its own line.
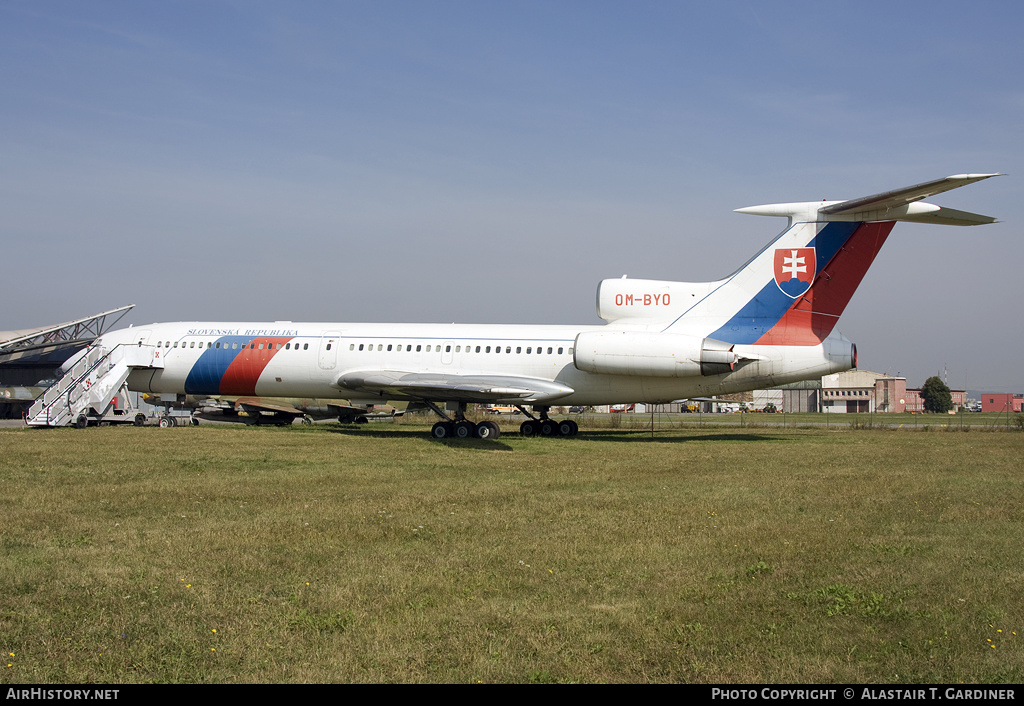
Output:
[0, 0, 1024, 391]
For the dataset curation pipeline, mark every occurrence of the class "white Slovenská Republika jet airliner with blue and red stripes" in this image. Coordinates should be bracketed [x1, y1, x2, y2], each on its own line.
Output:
[29, 174, 997, 439]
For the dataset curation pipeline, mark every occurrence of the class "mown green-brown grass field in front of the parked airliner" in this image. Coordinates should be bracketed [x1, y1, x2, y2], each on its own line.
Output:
[0, 415, 1024, 683]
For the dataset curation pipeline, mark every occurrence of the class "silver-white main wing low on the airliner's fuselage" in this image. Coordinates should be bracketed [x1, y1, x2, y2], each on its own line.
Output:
[337, 370, 574, 404]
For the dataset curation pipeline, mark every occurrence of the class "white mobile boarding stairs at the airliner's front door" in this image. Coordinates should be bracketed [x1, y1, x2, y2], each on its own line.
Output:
[26, 343, 164, 428]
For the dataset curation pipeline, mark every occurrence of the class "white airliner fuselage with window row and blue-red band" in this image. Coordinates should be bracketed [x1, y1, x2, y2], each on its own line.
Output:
[102, 322, 853, 405]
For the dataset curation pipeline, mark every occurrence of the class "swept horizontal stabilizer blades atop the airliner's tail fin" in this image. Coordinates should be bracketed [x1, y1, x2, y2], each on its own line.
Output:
[819, 174, 999, 225]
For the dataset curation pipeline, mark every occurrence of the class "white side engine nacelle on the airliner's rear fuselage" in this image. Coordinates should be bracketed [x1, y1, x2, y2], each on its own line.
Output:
[572, 331, 739, 377]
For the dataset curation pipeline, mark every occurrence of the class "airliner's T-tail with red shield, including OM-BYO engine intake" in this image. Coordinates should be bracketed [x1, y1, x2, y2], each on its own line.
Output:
[598, 174, 998, 346]
